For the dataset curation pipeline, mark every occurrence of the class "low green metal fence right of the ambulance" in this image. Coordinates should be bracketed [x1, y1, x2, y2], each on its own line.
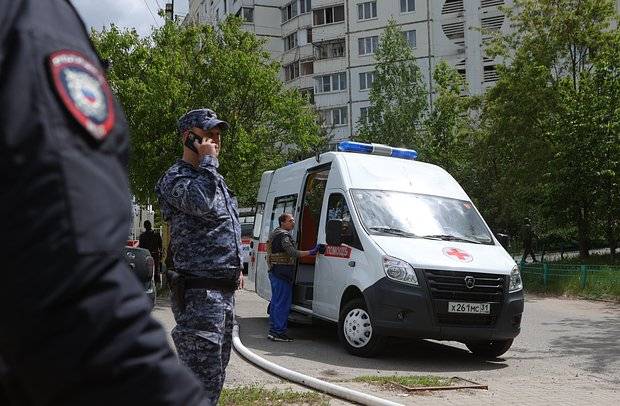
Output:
[521, 262, 620, 296]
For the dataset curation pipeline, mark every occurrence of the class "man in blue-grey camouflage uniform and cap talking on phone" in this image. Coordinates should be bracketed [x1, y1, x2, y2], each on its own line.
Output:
[155, 109, 243, 405]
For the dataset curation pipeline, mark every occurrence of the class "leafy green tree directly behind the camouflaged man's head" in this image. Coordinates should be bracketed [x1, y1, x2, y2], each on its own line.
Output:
[92, 18, 324, 204]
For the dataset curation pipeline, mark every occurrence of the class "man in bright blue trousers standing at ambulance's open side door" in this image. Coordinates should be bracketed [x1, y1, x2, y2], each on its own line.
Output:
[267, 213, 318, 341]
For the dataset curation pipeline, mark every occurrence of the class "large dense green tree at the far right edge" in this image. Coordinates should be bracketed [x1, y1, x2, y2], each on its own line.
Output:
[484, 0, 620, 256]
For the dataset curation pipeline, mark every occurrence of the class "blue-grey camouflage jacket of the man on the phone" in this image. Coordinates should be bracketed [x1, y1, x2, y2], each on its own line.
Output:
[155, 155, 242, 279]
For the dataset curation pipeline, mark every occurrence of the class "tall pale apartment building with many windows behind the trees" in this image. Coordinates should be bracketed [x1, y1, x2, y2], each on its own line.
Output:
[185, 0, 512, 141]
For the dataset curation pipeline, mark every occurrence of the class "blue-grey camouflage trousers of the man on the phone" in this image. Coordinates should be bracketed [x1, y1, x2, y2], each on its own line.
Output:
[172, 289, 234, 405]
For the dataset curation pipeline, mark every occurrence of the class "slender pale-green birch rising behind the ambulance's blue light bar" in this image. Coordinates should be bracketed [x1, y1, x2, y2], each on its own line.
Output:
[355, 20, 428, 148]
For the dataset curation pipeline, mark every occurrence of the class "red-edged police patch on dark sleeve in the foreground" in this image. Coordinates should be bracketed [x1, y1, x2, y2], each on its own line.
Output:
[48, 50, 115, 141]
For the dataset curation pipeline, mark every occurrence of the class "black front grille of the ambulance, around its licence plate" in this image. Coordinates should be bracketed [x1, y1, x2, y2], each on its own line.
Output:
[424, 269, 507, 326]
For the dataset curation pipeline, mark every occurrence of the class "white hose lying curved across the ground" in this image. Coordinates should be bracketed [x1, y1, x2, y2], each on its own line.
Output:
[233, 324, 402, 406]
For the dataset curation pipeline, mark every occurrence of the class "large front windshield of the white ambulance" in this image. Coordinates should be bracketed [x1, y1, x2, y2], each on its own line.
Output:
[351, 189, 493, 244]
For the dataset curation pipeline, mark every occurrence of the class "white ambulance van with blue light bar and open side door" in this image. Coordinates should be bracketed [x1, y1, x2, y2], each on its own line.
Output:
[249, 141, 523, 358]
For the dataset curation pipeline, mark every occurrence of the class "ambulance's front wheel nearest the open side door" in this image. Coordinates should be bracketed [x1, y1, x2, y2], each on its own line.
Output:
[338, 298, 384, 357]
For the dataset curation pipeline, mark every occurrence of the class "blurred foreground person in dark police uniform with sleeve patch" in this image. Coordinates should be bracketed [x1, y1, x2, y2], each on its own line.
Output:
[0, 0, 206, 405]
